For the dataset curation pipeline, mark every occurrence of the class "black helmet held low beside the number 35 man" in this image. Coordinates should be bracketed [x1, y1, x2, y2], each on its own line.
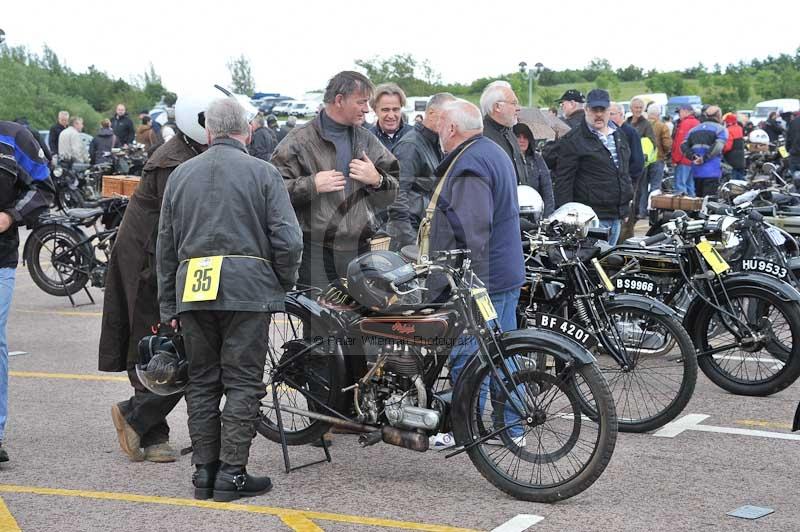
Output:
[136, 331, 189, 395]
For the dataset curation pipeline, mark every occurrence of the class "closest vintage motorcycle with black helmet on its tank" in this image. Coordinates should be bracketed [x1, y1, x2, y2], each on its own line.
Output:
[257, 250, 617, 502]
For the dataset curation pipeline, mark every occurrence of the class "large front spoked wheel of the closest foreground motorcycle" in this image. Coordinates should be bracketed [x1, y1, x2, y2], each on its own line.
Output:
[453, 352, 617, 502]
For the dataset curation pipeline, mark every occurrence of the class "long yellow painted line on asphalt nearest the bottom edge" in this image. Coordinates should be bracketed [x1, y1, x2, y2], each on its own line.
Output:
[0, 484, 475, 532]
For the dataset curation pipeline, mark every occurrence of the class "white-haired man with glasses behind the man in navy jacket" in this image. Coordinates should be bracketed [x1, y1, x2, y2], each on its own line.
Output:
[481, 81, 528, 184]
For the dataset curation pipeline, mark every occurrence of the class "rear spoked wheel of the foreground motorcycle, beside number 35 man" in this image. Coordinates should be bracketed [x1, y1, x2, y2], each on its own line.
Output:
[256, 310, 344, 445]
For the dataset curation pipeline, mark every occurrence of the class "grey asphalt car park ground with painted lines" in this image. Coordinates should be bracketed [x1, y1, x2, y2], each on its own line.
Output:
[0, 225, 800, 532]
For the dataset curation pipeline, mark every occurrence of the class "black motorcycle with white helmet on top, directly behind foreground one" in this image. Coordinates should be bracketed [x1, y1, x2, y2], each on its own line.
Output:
[518, 203, 697, 432]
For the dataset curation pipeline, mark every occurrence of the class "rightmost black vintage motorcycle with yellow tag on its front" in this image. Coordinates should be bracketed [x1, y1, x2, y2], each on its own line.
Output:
[600, 216, 800, 396]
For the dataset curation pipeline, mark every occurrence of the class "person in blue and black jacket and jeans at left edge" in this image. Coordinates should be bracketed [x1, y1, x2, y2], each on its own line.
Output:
[0, 122, 55, 462]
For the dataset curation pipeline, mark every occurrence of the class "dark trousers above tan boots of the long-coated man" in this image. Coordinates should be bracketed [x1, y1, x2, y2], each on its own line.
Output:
[119, 370, 183, 447]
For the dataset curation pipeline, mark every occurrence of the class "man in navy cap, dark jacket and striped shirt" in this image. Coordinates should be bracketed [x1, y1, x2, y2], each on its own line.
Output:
[553, 89, 633, 245]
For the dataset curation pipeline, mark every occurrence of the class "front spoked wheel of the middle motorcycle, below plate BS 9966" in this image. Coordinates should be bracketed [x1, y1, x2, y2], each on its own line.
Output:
[596, 305, 697, 432]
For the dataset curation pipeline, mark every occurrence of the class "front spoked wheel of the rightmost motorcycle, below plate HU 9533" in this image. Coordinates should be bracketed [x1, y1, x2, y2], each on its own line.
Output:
[692, 287, 800, 396]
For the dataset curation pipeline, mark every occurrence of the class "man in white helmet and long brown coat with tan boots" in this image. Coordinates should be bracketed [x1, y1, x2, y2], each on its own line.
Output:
[99, 88, 224, 462]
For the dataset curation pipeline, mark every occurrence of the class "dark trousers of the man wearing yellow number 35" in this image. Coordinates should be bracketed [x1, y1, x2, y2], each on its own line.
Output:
[180, 310, 269, 465]
